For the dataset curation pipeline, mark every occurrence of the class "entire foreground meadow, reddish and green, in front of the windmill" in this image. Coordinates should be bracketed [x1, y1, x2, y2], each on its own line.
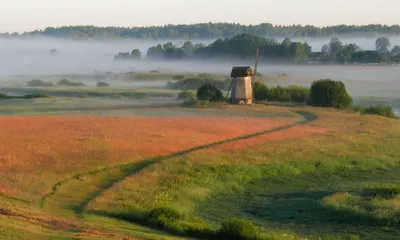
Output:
[0, 98, 400, 239]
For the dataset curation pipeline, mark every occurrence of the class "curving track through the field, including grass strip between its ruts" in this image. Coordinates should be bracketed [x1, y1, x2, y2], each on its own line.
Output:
[41, 111, 318, 217]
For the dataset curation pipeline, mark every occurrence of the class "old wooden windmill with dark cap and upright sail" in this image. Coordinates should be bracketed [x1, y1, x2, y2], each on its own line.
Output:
[227, 49, 258, 104]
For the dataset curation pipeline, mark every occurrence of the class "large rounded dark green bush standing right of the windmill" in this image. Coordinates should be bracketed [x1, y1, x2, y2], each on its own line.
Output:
[309, 79, 353, 108]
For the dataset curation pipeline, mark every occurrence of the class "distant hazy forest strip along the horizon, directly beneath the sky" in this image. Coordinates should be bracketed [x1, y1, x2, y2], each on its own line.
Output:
[1, 23, 400, 39]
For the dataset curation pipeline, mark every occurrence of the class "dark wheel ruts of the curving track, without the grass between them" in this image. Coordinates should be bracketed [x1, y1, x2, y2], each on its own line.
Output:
[40, 111, 318, 217]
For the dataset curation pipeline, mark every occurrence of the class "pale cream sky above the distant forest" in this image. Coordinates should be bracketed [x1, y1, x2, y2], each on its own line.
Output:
[0, 0, 400, 32]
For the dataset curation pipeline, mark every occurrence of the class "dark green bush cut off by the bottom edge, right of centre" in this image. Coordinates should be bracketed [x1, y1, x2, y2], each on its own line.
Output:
[218, 219, 260, 240]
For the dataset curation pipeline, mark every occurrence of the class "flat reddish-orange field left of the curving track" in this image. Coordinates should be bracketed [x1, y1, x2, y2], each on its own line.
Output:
[0, 117, 294, 199]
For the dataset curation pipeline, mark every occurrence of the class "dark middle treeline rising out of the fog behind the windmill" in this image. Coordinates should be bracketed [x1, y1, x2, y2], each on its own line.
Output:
[118, 34, 400, 64]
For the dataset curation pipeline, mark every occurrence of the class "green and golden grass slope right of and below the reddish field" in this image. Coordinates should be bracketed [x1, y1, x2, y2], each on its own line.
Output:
[0, 107, 400, 240]
